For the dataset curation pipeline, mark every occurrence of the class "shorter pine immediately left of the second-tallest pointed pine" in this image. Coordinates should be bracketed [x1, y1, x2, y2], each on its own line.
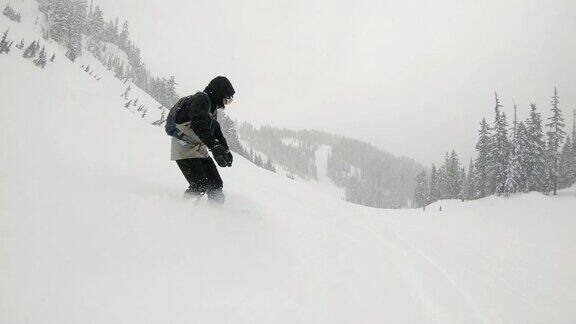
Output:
[474, 119, 492, 198]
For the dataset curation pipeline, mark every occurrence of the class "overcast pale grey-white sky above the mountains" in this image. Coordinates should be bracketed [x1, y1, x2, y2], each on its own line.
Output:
[95, 0, 576, 164]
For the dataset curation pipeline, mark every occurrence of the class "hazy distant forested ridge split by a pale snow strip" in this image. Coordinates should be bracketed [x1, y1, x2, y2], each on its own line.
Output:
[238, 123, 424, 208]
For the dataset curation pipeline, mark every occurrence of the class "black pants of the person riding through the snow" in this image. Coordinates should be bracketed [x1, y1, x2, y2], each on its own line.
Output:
[176, 158, 224, 193]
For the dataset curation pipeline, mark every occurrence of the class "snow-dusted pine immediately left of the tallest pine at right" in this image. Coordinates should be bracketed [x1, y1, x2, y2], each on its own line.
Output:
[525, 103, 546, 191]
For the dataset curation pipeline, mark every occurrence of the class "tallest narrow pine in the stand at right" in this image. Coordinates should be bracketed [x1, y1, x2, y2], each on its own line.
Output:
[546, 88, 566, 195]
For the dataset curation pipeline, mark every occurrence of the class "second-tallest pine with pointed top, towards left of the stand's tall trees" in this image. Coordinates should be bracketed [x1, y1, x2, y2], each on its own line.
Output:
[489, 94, 510, 195]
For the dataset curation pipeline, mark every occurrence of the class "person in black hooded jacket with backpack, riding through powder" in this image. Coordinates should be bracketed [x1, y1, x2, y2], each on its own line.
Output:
[166, 76, 235, 203]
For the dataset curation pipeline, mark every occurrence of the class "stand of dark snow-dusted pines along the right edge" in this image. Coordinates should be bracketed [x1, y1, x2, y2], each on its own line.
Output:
[413, 89, 576, 207]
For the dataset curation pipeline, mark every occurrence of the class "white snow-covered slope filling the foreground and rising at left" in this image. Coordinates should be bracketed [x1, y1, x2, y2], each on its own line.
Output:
[0, 5, 576, 324]
